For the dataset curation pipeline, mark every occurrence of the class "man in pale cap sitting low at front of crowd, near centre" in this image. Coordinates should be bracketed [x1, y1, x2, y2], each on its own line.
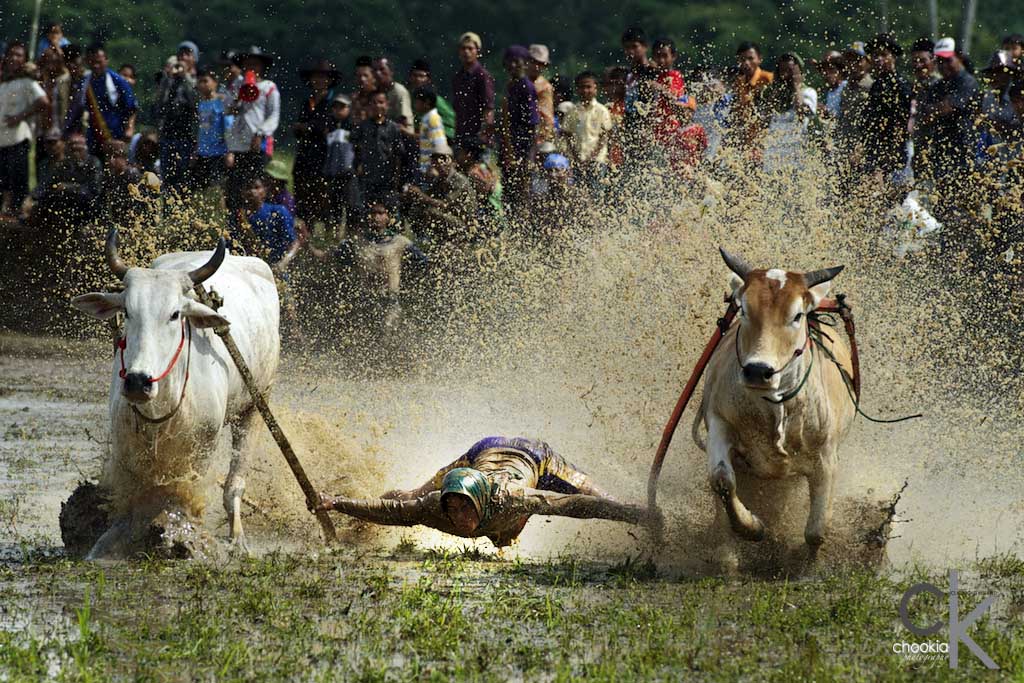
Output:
[402, 140, 477, 244]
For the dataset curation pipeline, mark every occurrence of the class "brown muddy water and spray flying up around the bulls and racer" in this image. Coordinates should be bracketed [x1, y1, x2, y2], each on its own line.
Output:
[0, 145, 1024, 566]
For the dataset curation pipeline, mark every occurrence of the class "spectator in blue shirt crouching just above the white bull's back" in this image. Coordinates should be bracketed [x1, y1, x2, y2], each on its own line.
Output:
[231, 176, 302, 275]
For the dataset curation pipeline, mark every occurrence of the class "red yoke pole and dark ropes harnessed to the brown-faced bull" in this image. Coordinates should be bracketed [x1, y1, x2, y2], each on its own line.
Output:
[647, 294, 922, 509]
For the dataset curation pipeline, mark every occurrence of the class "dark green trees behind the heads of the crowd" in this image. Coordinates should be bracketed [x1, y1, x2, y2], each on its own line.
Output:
[6, 0, 1024, 125]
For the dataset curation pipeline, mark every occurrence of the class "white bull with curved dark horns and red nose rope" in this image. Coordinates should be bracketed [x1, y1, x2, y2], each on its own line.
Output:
[72, 230, 281, 559]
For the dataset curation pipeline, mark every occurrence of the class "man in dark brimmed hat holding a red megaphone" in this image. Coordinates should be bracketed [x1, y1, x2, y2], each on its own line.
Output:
[224, 47, 281, 212]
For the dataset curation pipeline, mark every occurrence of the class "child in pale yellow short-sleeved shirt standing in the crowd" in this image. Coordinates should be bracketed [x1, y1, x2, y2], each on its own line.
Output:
[562, 71, 612, 191]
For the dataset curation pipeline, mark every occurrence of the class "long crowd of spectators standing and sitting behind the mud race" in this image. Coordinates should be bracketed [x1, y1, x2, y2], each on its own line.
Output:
[0, 25, 1024, 290]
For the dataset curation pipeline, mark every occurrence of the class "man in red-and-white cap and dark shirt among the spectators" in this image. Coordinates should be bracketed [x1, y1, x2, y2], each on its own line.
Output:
[918, 38, 981, 193]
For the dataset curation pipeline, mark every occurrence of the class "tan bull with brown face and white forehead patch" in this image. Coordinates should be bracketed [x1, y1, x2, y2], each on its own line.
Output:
[693, 250, 855, 567]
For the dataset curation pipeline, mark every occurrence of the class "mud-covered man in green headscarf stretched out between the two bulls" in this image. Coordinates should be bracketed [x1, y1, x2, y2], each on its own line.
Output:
[316, 436, 662, 548]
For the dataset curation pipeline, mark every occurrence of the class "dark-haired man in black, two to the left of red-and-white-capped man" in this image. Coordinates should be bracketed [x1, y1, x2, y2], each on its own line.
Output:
[863, 34, 910, 180]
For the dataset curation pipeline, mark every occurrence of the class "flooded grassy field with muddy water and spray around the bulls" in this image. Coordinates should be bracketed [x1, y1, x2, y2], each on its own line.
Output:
[0, 154, 1024, 681]
